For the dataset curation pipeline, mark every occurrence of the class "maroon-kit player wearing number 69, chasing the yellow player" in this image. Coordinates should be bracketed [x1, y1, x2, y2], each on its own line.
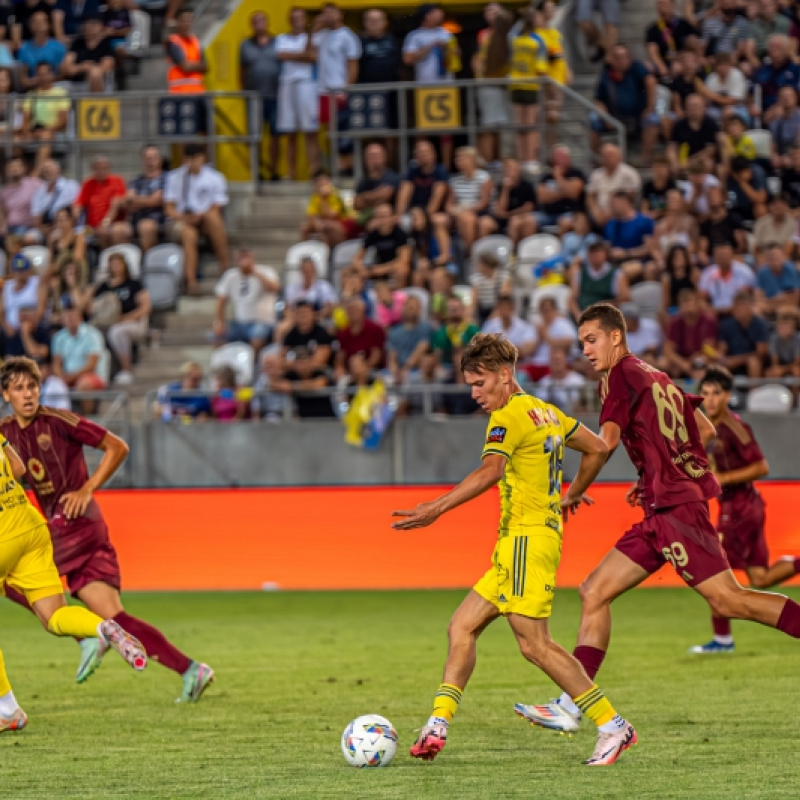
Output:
[515, 303, 800, 732]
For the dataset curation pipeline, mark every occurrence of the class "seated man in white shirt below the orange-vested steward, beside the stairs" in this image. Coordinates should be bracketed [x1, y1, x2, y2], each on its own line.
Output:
[164, 144, 230, 295]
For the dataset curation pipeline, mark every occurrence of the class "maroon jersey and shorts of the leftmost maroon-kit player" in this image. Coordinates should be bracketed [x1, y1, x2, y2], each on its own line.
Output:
[0, 406, 108, 575]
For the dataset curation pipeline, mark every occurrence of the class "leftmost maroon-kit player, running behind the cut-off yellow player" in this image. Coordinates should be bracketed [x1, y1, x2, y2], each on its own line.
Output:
[0, 357, 214, 702]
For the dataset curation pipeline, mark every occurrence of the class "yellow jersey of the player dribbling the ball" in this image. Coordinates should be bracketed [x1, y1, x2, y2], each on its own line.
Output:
[481, 392, 580, 537]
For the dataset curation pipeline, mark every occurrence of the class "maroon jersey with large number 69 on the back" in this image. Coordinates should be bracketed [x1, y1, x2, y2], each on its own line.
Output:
[600, 355, 720, 516]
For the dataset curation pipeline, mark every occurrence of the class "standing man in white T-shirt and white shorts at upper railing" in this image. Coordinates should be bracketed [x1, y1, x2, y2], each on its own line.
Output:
[275, 8, 319, 181]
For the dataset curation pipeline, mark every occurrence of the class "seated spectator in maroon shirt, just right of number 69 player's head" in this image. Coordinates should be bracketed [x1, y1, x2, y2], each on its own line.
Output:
[664, 288, 718, 380]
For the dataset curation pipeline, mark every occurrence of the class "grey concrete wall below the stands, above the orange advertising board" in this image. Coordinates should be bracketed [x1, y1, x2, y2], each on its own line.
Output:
[131, 415, 800, 487]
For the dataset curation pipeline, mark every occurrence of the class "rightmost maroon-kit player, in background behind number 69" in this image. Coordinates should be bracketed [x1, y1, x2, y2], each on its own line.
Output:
[689, 367, 800, 654]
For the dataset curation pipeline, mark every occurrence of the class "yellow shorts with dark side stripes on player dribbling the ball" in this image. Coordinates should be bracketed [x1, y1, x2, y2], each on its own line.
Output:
[473, 527, 561, 619]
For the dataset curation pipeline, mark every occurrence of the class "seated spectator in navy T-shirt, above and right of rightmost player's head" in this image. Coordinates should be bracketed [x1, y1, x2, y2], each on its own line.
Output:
[717, 289, 769, 378]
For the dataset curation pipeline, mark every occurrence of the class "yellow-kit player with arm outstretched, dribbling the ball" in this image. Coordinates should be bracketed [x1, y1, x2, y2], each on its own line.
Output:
[393, 334, 636, 766]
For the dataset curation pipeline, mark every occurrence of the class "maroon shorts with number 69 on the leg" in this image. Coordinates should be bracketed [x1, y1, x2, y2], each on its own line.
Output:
[614, 500, 730, 586]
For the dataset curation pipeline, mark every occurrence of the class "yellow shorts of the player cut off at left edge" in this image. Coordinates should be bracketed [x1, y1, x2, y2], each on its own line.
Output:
[0, 525, 64, 603]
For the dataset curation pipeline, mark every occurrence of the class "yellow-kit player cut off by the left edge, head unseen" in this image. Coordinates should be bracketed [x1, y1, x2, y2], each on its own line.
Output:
[0, 435, 147, 731]
